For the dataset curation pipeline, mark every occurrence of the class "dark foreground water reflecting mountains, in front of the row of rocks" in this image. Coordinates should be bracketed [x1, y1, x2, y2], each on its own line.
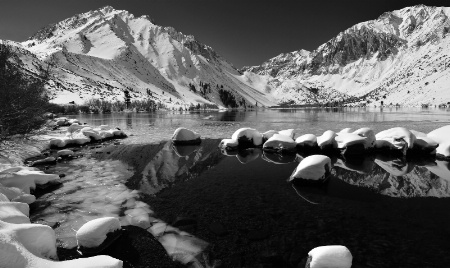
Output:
[89, 139, 450, 267]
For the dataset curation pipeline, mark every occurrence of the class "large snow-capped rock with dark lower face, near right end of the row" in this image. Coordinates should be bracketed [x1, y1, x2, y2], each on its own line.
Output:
[375, 127, 416, 154]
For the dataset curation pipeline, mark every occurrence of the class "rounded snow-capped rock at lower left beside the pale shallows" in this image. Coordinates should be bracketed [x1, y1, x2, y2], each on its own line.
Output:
[76, 217, 121, 248]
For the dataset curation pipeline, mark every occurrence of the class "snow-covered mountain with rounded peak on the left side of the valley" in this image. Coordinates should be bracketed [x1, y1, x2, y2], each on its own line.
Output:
[10, 6, 276, 108]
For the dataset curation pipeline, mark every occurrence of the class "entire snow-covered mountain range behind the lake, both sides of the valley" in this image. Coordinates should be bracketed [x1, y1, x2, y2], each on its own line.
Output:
[4, 5, 450, 108]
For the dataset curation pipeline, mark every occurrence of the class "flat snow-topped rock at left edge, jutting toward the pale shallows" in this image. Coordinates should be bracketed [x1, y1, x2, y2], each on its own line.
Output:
[0, 170, 59, 194]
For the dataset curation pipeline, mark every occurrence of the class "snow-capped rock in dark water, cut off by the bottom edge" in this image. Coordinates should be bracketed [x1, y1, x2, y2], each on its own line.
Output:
[306, 245, 353, 268]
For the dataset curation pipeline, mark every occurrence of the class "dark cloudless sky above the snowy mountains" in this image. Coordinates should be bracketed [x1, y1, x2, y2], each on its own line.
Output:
[0, 0, 450, 67]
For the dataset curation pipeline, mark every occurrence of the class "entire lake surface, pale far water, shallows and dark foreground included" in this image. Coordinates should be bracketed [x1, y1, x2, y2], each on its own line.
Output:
[31, 109, 450, 267]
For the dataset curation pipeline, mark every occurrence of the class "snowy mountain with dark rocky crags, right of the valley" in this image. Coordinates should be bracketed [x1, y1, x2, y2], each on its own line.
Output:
[242, 5, 450, 106]
